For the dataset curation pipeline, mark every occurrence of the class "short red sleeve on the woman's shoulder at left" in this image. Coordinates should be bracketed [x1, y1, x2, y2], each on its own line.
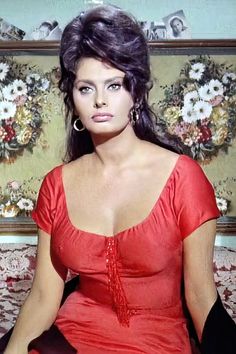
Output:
[32, 168, 58, 235]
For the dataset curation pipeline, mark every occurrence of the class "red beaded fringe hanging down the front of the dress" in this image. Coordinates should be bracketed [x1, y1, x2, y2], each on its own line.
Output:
[106, 237, 133, 327]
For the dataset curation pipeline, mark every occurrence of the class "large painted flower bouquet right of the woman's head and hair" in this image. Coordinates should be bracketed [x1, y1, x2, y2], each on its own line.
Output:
[156, 56, 236, 163]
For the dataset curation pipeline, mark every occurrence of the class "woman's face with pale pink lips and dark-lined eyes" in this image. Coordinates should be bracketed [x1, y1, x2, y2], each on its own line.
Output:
[73, 58, 134, 134]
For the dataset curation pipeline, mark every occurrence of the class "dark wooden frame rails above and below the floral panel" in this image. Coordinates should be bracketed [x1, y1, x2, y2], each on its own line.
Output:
[0, 39, 236, 237]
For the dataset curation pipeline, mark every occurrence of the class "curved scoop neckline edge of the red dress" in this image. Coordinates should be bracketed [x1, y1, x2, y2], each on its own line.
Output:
[60, 155, 184, 239]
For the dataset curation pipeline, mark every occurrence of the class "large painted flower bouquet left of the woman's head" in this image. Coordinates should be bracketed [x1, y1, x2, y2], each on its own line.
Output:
[0, 57, 60, 163]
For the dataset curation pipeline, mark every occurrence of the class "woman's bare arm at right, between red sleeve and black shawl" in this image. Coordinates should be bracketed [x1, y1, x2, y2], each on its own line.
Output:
[184, 220, 217, 341]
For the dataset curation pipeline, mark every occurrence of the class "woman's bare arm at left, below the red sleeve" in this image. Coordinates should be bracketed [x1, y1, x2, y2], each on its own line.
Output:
[4, 230, 64, 354]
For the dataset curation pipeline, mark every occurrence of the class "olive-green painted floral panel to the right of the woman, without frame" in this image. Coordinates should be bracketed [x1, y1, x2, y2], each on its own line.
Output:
[150, 49, 236, 216]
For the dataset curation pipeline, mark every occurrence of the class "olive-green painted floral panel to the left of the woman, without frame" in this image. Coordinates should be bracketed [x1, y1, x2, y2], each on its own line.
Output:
[0, 53, 65, 218]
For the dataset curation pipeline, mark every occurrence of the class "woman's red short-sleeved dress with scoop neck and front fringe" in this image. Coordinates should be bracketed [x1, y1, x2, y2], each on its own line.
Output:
[33, 155, 219, 354]
